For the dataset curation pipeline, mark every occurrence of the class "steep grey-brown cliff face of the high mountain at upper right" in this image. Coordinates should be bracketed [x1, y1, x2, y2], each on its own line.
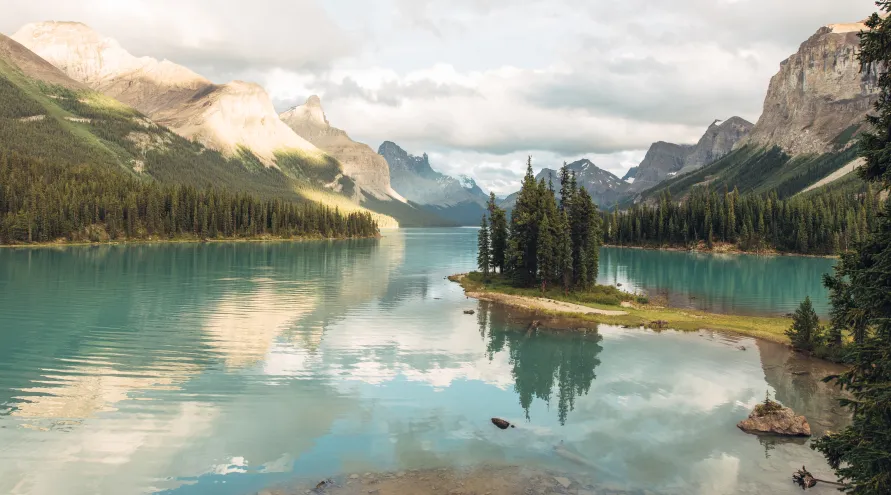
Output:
[745, 23, 878, 155]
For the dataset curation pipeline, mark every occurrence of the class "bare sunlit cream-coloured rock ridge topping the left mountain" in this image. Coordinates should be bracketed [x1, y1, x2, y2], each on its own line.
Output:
[13, 22, 324, 166]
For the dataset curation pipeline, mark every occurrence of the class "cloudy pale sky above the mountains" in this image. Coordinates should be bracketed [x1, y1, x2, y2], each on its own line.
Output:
[0, 0, 875, 195]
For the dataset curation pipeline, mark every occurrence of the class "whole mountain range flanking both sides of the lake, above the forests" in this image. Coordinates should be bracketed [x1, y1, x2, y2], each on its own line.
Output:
[0, 15, 878, 227]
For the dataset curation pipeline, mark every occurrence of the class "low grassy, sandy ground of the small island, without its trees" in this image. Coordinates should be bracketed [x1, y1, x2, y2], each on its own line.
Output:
[449, 272, 791, 344]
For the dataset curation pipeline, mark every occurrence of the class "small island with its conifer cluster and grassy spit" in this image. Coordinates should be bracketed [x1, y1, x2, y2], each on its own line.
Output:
[460, 159, 789, 344]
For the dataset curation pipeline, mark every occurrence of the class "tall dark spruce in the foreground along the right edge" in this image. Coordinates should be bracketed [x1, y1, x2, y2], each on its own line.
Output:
[813, 5, 891, 495]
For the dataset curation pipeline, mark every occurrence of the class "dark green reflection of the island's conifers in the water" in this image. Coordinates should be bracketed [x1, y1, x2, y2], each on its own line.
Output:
[477, 302, 603, 425]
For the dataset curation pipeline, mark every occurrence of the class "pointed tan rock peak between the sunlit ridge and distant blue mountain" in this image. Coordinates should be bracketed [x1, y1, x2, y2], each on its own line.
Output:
[279, 96, 405, 202]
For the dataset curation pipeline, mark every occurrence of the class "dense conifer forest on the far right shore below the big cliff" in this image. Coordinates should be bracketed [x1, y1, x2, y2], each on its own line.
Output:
[603, 180, 880, 255]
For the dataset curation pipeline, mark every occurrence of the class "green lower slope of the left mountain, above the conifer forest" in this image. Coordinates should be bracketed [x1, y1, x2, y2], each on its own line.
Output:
[0, 35, 397, 227]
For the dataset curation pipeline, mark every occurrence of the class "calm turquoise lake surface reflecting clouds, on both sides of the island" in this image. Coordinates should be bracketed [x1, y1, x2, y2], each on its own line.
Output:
[0, 229, 845, 495]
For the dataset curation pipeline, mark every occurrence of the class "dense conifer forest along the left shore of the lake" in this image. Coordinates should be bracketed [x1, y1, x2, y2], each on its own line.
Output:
[0, 150, 378, 244]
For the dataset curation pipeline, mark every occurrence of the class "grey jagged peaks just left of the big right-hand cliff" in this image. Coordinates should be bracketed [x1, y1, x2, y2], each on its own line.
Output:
[630, 117, 753, 192]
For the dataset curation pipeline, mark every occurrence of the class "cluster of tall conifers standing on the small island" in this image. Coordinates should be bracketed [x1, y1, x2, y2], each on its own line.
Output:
[477, 158, 603, 292]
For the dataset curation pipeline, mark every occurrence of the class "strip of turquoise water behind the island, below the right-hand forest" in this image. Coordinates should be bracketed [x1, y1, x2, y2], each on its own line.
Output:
[598, 248, 836, 316]
